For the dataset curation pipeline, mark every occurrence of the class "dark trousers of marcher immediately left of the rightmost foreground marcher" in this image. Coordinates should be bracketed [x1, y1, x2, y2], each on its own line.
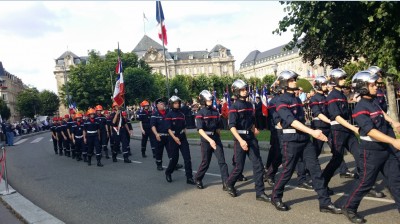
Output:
[322, 130, 360, 186]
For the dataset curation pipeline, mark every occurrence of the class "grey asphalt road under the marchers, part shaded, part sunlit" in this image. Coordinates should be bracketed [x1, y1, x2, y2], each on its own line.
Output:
[3, 133, 400, 224]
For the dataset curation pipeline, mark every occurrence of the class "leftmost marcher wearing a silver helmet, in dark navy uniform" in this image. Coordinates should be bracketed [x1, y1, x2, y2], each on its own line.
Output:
[165, 96, 195, 184]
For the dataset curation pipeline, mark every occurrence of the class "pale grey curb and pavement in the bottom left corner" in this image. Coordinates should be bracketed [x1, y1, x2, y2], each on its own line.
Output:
[0, 180, 65, 224]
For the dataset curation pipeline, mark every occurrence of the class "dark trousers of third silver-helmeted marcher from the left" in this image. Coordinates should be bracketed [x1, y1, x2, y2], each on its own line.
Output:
[226, 135, 265, 196]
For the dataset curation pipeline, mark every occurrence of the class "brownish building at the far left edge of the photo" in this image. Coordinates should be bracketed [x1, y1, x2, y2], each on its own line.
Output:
[0, 61, 27, 122]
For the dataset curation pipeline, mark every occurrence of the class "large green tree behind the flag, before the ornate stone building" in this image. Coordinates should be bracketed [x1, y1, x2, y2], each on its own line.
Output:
[60, 50, 153, 110]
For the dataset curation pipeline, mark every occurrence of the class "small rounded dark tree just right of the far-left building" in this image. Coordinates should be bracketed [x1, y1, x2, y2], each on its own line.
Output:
[16, 88, 42, 118]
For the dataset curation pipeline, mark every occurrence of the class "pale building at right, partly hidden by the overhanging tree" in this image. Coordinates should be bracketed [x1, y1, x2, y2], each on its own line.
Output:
[239, 45, 331, 79]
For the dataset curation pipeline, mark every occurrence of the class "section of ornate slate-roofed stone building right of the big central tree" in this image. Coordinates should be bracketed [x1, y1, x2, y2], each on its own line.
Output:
[132, 35, 235, 77]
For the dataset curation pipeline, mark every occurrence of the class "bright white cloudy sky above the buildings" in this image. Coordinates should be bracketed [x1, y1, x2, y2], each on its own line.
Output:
[0, 1, 292, 93]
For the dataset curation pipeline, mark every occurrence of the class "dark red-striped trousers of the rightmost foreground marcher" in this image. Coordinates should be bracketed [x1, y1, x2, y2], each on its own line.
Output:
[344, 149, 400, 211]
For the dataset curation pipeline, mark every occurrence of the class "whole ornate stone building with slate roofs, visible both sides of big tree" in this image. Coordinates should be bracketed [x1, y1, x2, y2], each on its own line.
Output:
[53, 35, 235, 116]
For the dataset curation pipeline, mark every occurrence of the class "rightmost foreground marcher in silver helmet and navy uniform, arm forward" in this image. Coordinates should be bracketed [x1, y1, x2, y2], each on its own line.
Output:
[343, 71, 400, 223]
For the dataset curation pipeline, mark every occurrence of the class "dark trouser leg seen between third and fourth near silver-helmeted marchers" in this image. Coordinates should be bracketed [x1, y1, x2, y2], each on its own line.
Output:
[265, 129, 282, 179]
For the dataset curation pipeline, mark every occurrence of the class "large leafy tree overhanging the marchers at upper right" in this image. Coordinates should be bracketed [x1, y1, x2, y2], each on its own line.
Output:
[273, 1, 400, 120]
